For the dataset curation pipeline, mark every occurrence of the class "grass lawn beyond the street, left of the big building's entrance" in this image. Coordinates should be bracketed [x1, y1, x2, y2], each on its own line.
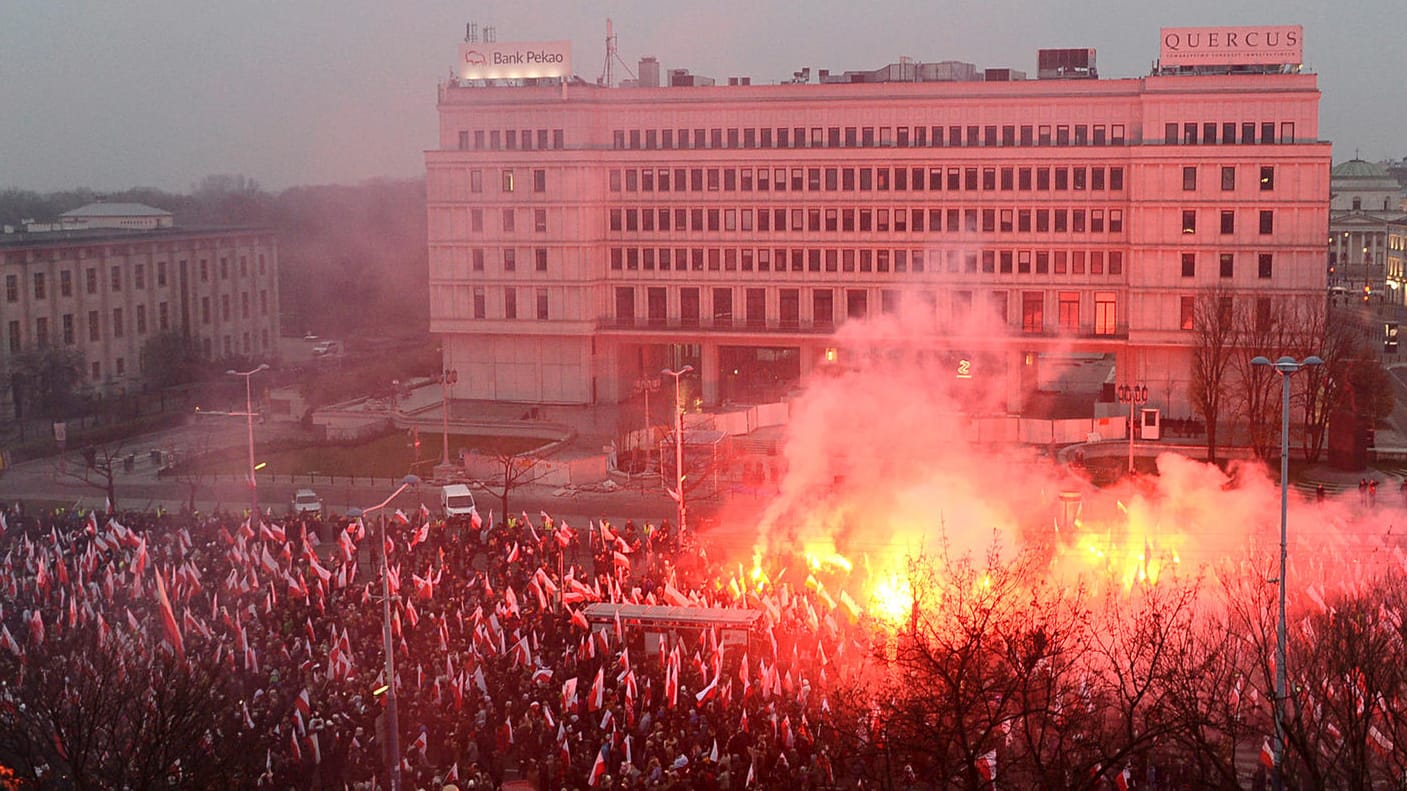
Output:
[197, 432, 545, 477]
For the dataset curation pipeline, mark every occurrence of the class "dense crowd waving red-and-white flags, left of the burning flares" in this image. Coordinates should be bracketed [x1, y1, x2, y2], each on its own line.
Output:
[0, 495, 865, 790]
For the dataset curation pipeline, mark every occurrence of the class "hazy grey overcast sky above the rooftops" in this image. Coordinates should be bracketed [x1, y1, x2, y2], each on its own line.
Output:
[0, 0, 1407, 191]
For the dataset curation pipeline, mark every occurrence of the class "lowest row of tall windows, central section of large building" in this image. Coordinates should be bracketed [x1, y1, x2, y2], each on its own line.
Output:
[615, 286, 1119, 335]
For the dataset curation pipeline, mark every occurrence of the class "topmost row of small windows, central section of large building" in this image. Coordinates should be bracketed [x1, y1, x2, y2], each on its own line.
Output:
[611, 124, 1126, 151]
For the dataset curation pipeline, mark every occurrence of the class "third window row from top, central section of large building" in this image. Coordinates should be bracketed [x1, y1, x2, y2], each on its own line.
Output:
[606, 207, 1125, 234]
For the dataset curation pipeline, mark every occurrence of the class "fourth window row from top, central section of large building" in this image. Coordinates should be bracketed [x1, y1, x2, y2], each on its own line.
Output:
[611, 248, 1124, 276]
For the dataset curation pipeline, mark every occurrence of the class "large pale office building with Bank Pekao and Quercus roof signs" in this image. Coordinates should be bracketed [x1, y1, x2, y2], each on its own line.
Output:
[426, 28, 1331, 417]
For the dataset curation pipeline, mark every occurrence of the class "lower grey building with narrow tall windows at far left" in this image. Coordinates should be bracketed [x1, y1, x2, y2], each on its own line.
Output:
[0, 215, 279, 415]
